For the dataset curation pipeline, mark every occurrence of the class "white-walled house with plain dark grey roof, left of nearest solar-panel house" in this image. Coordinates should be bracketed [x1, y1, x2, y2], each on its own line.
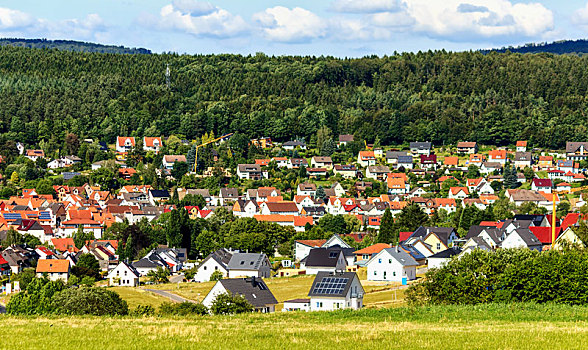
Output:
[202, 277, 278, 313]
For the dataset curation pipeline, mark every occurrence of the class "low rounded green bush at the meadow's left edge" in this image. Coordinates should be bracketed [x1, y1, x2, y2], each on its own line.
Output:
[53, 288, 129, 316]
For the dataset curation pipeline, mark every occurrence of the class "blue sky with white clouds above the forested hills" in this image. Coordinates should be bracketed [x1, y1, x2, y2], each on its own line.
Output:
[0, 0, 588, 57]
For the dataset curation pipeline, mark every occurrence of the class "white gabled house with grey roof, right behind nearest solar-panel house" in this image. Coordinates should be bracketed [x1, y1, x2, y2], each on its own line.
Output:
[366, 246, 419, 284]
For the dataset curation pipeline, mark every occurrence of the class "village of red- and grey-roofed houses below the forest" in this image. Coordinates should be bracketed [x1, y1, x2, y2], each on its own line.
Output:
[0, 134, 588, 312]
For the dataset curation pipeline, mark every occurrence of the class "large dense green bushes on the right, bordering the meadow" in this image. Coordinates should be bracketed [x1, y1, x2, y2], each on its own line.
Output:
[407, 249, 588, 305]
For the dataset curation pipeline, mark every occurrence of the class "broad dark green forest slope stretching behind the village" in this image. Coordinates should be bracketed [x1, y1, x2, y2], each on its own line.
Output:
[0, 47, 588, 154]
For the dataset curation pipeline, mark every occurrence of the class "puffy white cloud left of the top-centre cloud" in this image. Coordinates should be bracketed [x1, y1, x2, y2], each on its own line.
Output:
[157, 0, 249, 38]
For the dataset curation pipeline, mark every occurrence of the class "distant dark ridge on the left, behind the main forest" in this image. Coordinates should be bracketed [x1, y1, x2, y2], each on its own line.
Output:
[0, 38, 151, 54]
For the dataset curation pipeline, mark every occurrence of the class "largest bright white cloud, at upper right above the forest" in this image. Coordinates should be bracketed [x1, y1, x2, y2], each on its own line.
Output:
[404, 0, 554, 41]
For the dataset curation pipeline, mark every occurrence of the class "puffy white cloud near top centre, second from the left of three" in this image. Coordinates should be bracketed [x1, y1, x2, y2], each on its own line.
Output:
[253, 6, 328, 43]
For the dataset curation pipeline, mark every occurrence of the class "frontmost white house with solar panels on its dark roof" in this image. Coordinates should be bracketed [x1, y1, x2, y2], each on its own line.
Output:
[308, 272, 364, 311]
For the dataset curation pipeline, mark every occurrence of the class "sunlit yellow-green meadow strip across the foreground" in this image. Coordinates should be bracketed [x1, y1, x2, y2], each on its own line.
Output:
[0, 304, 588, 350]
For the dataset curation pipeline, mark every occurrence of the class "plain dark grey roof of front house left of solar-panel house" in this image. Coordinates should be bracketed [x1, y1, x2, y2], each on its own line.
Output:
[219, 277, 278, 308]
